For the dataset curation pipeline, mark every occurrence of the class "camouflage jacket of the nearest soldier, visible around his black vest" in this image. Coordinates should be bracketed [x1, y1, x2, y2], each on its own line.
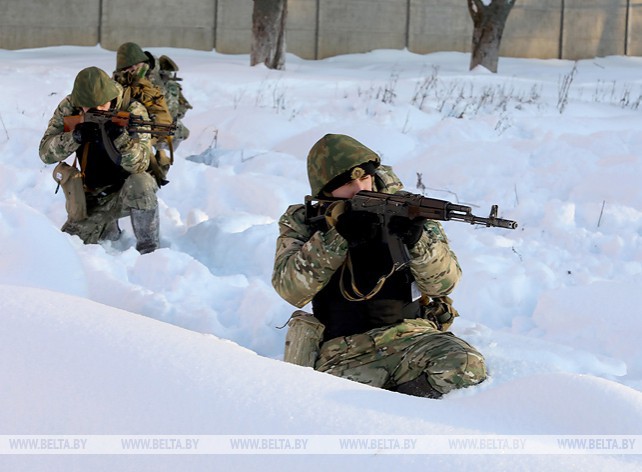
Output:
[272, 166, 461, 308]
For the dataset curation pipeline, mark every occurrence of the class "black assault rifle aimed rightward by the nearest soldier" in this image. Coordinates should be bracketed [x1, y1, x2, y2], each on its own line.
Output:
[305, 190, 517, 268]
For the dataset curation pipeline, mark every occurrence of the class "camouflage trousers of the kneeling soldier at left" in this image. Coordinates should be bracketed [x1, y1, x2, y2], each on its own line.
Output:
[61, 172, 158, 244]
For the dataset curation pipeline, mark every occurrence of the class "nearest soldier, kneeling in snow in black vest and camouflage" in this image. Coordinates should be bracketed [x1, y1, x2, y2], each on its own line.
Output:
[272, 134, 486, 398]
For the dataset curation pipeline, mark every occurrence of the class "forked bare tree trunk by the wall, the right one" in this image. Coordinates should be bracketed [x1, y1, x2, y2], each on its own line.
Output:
[468, 0, 516, 72]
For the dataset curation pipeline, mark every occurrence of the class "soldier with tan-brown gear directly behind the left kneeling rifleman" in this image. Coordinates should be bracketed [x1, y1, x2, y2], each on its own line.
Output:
[113, 42, 174, 185]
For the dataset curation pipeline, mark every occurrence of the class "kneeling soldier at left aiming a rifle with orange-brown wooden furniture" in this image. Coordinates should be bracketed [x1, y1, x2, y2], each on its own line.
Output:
[39, 67, 159, 254]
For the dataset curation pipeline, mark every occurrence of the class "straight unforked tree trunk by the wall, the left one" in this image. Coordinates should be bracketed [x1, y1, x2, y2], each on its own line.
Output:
[250, 0, 288, 70]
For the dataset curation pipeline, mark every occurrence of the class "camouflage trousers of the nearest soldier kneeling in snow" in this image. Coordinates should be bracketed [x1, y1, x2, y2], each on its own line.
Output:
[315, 319, 486, 394]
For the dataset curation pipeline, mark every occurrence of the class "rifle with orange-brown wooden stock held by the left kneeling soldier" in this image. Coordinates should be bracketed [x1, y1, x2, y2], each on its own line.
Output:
[63, 109, 176, 165]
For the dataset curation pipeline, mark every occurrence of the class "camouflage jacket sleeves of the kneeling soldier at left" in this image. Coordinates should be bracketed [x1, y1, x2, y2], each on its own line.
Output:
[39, 88, 152, 174]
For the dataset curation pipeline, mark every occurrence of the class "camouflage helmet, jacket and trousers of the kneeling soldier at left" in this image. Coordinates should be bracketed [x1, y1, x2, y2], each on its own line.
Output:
[39, 67, 158, 251]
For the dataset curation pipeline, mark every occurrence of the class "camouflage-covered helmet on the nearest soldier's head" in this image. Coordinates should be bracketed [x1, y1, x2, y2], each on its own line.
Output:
[308, 134, 381, 197]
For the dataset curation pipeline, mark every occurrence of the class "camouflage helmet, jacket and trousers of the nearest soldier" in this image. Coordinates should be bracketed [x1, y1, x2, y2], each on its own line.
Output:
[272, 135, 486, 396]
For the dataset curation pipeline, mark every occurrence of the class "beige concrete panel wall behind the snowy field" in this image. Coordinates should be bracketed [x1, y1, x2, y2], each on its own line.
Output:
[0, 0, 642, 59]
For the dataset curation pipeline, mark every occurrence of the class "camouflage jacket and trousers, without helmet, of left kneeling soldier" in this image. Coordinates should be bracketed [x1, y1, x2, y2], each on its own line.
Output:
[39, 85, 158, 244]
